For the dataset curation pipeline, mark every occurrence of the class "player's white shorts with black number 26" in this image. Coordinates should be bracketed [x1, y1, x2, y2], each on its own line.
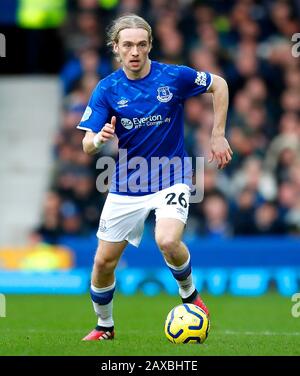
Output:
[97, 184, 190, 247]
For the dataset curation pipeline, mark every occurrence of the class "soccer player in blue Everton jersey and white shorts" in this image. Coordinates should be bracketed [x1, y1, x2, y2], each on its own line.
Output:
[78, 14, 232, 341]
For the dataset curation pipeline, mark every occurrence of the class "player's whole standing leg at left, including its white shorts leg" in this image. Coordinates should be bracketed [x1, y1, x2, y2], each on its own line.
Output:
[84, 194, 150, 340]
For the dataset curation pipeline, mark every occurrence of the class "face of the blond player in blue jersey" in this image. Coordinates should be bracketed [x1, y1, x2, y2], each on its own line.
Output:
[114, 29, 151, 78]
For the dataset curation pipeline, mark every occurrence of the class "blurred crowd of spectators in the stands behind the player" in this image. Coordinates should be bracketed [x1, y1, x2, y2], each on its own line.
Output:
[31, 0, 300, 243]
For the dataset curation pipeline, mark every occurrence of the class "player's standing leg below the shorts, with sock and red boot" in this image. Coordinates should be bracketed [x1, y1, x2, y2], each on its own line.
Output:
[83, 240, 127, 341]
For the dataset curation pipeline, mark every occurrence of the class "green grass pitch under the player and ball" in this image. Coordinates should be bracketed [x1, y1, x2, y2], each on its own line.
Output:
[0, 292, 300, 356]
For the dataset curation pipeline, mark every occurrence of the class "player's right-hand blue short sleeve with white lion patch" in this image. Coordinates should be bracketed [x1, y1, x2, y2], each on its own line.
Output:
[179, 65, 213, 99]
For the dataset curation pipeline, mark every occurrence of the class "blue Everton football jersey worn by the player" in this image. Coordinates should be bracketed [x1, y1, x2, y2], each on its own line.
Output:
[77, 61, 212, 196]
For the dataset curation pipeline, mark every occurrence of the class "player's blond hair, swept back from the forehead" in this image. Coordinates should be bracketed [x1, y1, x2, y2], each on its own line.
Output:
[107, 13, 153, 46]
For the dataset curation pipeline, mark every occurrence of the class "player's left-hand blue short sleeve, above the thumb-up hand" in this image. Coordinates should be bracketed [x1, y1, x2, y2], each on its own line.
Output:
[77, 81, 110, 133]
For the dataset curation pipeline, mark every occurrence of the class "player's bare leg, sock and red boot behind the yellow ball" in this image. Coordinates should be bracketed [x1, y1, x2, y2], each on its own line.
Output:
[155, 218, 209, 315]
